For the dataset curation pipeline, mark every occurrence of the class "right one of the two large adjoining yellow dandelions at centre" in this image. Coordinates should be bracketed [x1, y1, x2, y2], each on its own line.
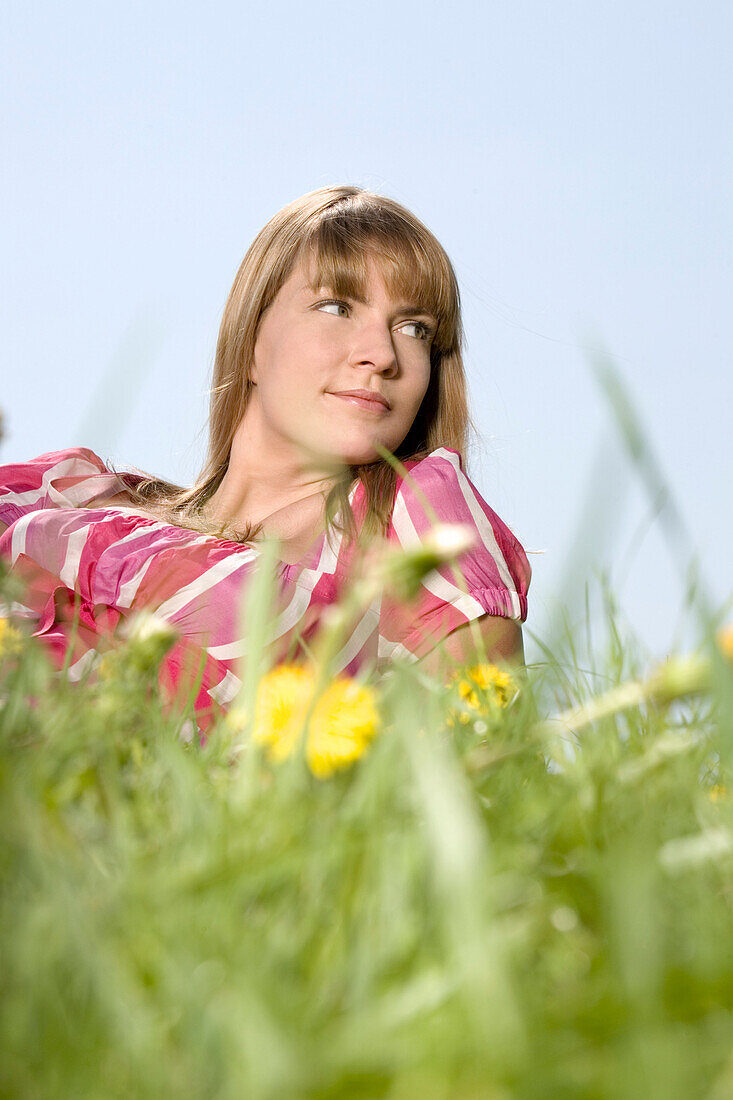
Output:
[306, 677, 379, 779]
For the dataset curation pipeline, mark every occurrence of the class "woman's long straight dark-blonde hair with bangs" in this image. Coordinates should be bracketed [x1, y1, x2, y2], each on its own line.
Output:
[108, 186, 473, 542]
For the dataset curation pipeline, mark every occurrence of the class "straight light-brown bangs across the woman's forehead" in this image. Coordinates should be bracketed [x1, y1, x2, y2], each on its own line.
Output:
[298, 206, 460, 352]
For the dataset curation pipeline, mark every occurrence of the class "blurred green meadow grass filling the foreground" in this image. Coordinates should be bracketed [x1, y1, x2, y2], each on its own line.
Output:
[0, 558, 733, 1100]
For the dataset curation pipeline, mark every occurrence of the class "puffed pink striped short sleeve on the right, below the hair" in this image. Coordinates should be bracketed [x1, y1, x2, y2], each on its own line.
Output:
[380, 447, 532, 658]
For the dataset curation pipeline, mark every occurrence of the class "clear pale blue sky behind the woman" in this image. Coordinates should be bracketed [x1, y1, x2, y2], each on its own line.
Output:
[0, 0, 733, 658]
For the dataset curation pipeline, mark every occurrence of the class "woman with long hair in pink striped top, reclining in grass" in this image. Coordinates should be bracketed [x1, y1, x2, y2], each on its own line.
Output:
[0, 186, 530, 729]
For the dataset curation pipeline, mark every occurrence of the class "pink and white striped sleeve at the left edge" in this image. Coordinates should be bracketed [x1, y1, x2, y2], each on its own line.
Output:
[0, 447, 113, 526]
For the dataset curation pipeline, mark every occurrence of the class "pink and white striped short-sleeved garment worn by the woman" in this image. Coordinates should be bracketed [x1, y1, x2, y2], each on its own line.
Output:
[0, 447, 530, 734]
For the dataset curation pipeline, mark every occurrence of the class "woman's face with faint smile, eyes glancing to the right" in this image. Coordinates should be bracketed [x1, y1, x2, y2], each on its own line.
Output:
[248, 256, 437, 465]
